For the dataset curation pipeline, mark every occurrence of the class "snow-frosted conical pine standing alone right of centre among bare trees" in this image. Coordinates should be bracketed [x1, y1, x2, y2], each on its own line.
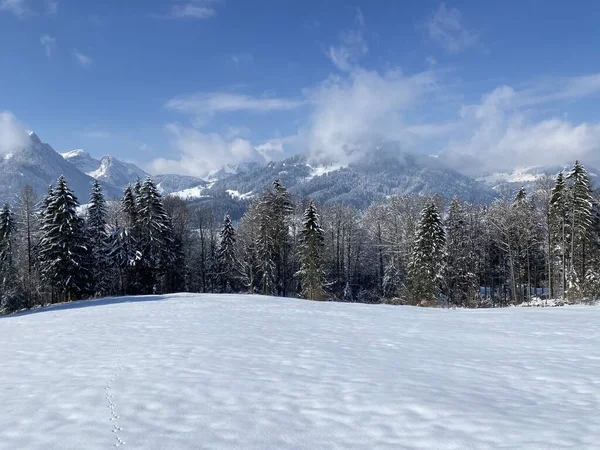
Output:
[409, 201, 446, 305]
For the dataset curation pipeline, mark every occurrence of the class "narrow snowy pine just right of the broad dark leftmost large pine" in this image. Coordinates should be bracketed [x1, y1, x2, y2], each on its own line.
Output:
[85, 180, 112, 295]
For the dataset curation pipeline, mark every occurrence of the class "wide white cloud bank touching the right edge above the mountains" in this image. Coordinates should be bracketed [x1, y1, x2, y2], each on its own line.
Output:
[442, 80, 600, 174]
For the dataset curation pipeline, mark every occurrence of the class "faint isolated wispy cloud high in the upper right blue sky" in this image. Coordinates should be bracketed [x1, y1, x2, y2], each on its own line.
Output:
[427, 3, 479, 53]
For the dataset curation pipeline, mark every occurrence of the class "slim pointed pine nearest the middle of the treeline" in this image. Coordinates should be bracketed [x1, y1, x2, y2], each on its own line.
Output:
[297, 200, 325, 300]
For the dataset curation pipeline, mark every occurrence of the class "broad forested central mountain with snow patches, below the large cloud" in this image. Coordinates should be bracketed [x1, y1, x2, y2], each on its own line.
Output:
[174, 150, 495, 208]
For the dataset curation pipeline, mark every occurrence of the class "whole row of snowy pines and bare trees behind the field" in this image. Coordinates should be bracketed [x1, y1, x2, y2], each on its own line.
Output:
[0, 162, 600, 312]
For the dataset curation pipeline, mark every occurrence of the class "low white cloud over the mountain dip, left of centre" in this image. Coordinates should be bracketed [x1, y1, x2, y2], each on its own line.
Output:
[146, 124, 264, 177]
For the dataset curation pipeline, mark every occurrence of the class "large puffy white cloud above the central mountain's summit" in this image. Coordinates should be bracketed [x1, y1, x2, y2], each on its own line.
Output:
[300, 69, 437, 162]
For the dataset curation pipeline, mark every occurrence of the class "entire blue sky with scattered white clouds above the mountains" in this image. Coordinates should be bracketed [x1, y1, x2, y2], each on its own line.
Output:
[0, 0, 600, 176]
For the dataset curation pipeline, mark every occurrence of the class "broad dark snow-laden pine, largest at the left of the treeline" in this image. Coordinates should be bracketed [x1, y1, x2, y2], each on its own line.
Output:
[39, 176, 89, 300]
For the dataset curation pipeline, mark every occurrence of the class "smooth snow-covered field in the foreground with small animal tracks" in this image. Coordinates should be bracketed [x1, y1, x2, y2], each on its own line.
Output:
[0, 294, 600, 449]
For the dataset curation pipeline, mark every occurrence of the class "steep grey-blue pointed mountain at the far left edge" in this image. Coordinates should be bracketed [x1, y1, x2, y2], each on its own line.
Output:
[0, 132, 119, 203]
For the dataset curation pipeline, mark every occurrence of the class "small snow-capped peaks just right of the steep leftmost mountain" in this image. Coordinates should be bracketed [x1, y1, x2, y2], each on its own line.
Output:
[61, 149, 148, 189]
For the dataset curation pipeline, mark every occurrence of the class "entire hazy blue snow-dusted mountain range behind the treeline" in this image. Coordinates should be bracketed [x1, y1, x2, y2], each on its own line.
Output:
[0, 128, 596, 209]
